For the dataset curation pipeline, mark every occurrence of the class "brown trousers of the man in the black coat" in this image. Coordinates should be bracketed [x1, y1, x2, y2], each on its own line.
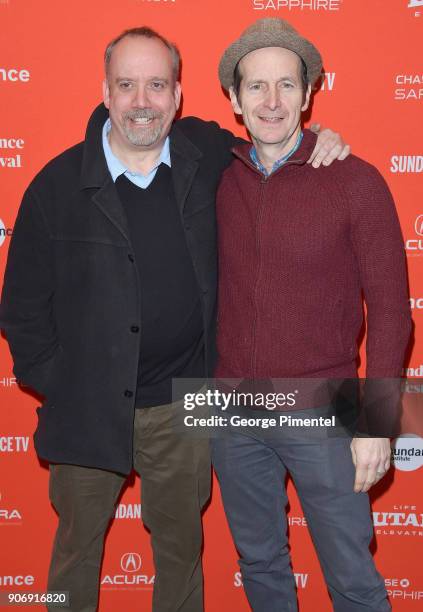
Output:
[48, 404, 211, 612]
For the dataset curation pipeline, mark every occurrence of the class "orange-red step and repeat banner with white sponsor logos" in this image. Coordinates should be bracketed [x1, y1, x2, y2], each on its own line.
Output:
[0, 0, 423, 612]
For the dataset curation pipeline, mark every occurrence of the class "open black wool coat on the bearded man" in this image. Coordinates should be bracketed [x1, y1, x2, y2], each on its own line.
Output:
[0, 105, 235, 474]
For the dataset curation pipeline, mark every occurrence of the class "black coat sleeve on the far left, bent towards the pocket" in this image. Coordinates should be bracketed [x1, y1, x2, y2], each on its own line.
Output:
[0, 187, 60, 395]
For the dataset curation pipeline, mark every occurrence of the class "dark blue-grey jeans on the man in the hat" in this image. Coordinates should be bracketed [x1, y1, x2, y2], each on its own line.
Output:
[212, 411, 391, 612]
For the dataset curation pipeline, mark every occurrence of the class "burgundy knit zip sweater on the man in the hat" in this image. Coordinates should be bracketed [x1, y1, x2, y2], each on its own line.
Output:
[216, 130, 411, 388]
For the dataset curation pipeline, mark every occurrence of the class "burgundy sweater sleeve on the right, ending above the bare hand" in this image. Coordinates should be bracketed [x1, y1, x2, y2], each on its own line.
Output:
[349, 163, 411, 437]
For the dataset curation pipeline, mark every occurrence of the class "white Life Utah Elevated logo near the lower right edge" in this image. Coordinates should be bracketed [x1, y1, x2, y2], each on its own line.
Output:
[373, 504, 423, 537]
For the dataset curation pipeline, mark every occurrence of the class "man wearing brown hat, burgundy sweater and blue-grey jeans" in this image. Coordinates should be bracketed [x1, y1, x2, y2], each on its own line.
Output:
[213, 19, 410, 612]
